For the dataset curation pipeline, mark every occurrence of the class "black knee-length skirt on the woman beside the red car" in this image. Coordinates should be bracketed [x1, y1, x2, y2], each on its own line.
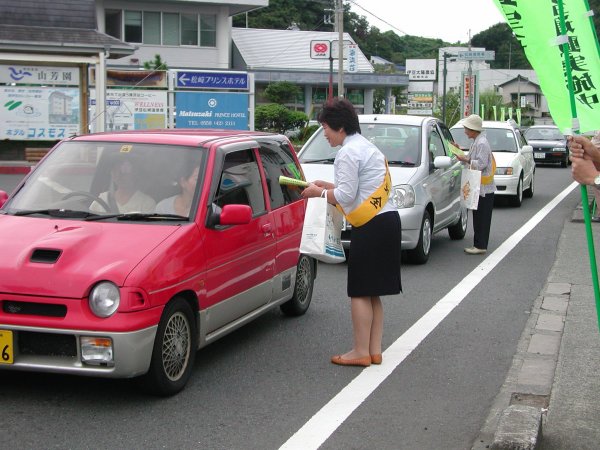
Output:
[348, 211, 402, 297]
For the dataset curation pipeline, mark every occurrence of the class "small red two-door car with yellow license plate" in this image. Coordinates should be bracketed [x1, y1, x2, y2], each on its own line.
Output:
[0, 130, 317, 395]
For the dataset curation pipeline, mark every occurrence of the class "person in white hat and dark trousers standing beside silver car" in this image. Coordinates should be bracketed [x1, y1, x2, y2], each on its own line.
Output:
[457, 114, 496, 255]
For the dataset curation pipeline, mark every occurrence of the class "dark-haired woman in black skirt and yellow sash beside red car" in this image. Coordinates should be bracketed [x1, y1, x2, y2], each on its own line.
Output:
[302, 98, 402, 367]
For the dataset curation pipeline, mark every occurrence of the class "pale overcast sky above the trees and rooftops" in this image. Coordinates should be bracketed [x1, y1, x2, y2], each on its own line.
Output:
[350, 0, 504, 43]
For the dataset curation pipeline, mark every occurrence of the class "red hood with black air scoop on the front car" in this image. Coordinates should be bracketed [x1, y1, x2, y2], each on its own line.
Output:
[0, 216, 180, 298]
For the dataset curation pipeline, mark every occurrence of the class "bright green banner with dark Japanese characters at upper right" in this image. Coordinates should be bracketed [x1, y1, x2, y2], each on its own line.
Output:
[494, 0, 600, 134]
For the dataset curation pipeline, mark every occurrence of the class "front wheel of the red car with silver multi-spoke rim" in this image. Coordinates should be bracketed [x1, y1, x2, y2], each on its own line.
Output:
[143, 298, 198, 396]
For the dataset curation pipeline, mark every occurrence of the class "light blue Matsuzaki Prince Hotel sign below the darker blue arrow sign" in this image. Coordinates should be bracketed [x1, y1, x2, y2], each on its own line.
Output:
[175, 92, 250, 130]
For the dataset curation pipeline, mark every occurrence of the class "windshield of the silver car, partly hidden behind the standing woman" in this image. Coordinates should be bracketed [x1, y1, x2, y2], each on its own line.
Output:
[299, 123, 421, 166]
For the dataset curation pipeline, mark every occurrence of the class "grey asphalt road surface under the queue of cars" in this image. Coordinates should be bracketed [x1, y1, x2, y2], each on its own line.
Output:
[0, 167, 580, 450]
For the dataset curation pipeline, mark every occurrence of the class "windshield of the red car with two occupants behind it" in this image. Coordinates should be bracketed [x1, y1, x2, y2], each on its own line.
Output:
[3, 141, 205, 221]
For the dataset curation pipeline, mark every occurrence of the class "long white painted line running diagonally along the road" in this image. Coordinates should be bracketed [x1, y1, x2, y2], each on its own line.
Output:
[280, 183, 579, 450]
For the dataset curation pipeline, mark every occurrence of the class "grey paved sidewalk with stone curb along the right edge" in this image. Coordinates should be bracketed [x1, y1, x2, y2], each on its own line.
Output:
[472, 205, 600, 450]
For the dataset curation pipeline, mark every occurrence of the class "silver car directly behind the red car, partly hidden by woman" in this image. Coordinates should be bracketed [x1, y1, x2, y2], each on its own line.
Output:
[298, 114, 468, 264]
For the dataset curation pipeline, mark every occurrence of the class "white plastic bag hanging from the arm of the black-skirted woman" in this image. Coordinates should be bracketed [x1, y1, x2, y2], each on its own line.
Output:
[300, 197, 346, 263]
